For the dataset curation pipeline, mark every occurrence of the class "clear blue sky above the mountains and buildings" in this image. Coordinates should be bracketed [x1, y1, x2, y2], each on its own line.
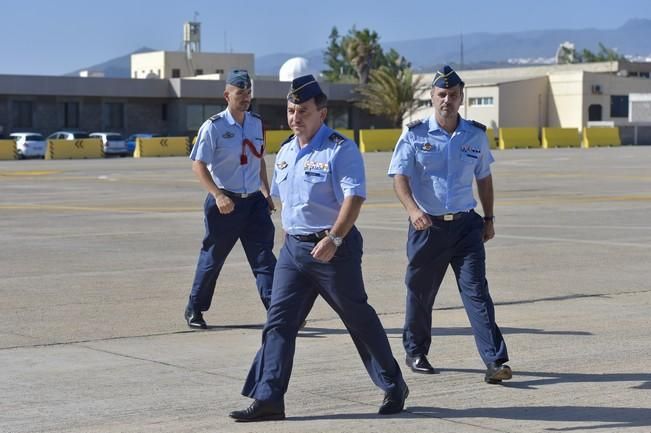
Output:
[0, 0, 651, 75]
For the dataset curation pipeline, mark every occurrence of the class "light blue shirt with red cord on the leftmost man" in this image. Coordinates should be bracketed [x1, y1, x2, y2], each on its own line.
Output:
[190, 108, 264, 193]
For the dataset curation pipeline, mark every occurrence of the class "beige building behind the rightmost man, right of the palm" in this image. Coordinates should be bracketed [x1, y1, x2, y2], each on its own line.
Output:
[412, 61, 651, 130]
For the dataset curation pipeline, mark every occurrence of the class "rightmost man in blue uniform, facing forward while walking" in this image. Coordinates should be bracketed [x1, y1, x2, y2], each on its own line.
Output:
[389, 66, 512, 383]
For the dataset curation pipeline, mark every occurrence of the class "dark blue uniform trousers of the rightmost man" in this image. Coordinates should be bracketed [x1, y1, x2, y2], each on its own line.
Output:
[402, 211, 508, 364]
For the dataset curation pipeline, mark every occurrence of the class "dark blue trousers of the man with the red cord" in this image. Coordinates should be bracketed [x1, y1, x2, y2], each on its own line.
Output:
[189, 192, 276, 311]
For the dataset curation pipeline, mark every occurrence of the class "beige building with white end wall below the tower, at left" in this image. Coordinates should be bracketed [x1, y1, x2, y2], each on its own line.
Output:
[131, 51, 255, 79]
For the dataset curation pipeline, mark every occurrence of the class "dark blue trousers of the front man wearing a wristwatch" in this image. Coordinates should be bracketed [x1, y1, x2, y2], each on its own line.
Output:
[242, 228, 404, 400]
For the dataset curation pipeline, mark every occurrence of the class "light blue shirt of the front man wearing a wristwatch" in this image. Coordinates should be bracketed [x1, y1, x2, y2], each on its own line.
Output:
[271, 125, 366, 235]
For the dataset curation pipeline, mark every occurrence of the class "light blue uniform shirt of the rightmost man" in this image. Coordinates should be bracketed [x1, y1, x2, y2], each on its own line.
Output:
[389, 115, 494, 215]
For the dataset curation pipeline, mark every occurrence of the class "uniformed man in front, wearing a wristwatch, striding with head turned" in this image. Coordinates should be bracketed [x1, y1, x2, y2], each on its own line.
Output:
[230, 75, 409, 421]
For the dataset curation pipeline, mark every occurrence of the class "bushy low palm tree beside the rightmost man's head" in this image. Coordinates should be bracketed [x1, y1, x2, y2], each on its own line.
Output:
[355, 66, 421, 128]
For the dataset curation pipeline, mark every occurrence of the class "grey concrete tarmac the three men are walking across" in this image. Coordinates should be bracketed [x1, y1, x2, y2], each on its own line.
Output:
[0, 146, 651, 433]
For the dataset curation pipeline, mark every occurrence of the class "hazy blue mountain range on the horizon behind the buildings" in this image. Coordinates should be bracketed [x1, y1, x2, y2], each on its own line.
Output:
[66, 19, 651, 78]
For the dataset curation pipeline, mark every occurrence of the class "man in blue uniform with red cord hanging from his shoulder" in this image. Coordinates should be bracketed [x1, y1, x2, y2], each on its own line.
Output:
[185, 70, 276, 329]
